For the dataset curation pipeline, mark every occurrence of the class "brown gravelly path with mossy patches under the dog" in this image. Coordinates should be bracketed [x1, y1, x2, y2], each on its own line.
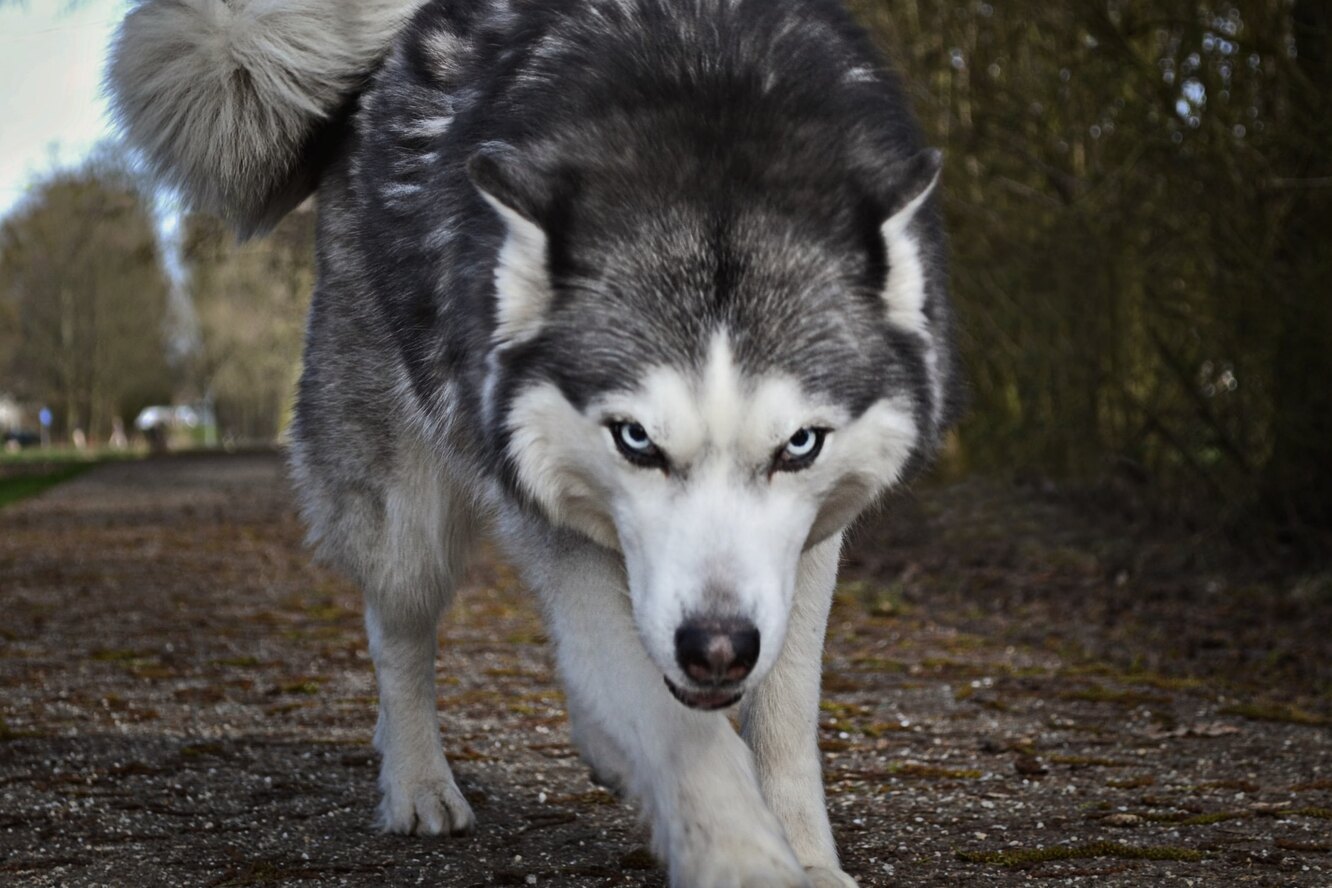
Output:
[0, 455, 1332, 888]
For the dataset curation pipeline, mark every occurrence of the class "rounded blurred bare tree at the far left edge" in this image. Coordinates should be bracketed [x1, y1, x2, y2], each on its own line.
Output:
[0, 161, 174, 438]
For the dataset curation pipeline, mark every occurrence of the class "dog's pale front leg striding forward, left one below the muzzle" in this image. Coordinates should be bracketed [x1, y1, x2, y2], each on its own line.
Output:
[525, 534, 811, 888]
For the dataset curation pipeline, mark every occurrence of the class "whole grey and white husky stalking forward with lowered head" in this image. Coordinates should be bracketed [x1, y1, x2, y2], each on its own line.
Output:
[111, 0, 954, 888]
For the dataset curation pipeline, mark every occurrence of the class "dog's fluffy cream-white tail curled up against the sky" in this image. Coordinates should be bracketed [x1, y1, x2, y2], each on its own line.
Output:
[108, 0, 422, 236]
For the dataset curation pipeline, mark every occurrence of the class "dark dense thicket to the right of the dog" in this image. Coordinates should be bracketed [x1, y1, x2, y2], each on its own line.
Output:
[852, 0, 1332, 543]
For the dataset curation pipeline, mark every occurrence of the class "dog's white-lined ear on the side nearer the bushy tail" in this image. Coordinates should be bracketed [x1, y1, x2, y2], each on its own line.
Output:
[468, 142, 554, 342]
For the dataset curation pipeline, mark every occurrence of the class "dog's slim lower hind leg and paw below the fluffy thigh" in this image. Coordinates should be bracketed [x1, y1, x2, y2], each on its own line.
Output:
[365, 599, 476, 835]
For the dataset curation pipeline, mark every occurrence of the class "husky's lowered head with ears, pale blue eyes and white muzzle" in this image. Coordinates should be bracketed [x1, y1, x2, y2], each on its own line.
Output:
[469, 131, 948, 708]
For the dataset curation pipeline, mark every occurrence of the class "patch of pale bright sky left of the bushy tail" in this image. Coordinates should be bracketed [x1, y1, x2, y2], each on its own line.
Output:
[0, 0, 129, 217]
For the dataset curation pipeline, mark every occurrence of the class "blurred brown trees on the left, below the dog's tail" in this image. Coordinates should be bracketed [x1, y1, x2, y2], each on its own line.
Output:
[0, 165, 314, 446]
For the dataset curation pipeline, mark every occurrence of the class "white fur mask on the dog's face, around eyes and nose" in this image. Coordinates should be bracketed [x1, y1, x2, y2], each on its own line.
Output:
[509, 335, 918, 686]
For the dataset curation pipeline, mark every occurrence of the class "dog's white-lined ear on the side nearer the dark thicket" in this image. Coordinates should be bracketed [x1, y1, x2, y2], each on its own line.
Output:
[879, 148, 943, 338]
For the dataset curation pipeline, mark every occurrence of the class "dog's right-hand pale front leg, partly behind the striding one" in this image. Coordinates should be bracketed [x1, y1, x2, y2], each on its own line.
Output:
[741, 534, 855, 888]
